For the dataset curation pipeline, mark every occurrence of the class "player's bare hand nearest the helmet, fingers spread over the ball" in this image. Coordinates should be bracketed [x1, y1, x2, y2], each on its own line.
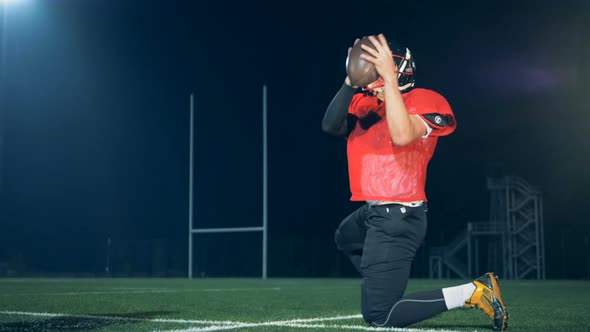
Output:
[361, 34, 398, 85]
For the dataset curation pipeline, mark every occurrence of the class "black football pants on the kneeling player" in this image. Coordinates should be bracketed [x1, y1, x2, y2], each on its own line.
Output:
[335, 204, 447, 327]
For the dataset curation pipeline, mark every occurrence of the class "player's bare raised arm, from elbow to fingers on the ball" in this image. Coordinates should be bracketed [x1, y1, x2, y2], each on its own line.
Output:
[361, 34, 427, 146]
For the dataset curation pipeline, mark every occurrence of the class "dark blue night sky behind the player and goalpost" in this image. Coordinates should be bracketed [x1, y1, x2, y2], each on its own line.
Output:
[0, 0, 590, 277]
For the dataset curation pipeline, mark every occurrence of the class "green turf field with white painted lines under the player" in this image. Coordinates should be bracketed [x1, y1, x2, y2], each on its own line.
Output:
[0, 279, 590, 332]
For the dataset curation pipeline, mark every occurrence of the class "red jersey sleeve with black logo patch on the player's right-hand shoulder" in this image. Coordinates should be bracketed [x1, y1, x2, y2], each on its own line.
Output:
[405, 89, 457, 136]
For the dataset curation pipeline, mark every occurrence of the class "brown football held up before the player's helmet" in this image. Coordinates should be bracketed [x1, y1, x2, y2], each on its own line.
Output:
[346, 37, 379, 86]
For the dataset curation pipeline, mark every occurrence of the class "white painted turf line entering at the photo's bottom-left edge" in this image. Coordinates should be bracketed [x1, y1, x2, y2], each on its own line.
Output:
[0, 311, 236, 326]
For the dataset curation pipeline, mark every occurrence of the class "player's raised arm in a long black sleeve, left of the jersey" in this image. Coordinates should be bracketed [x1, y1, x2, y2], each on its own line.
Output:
[322, 83, 356, 136]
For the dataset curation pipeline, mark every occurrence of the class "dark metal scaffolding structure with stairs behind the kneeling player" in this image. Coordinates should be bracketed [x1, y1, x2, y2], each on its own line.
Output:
[429, 176, 545, 279]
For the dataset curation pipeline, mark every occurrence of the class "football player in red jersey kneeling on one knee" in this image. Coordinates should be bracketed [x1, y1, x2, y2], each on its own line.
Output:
[322, 34, 508, 331]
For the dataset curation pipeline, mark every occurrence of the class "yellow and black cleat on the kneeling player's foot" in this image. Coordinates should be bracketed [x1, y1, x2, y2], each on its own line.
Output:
[465, 272, 508, 331]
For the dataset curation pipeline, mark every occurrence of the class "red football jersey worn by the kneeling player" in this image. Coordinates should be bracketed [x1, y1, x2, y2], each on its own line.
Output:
[347, 89, 456, 202]
